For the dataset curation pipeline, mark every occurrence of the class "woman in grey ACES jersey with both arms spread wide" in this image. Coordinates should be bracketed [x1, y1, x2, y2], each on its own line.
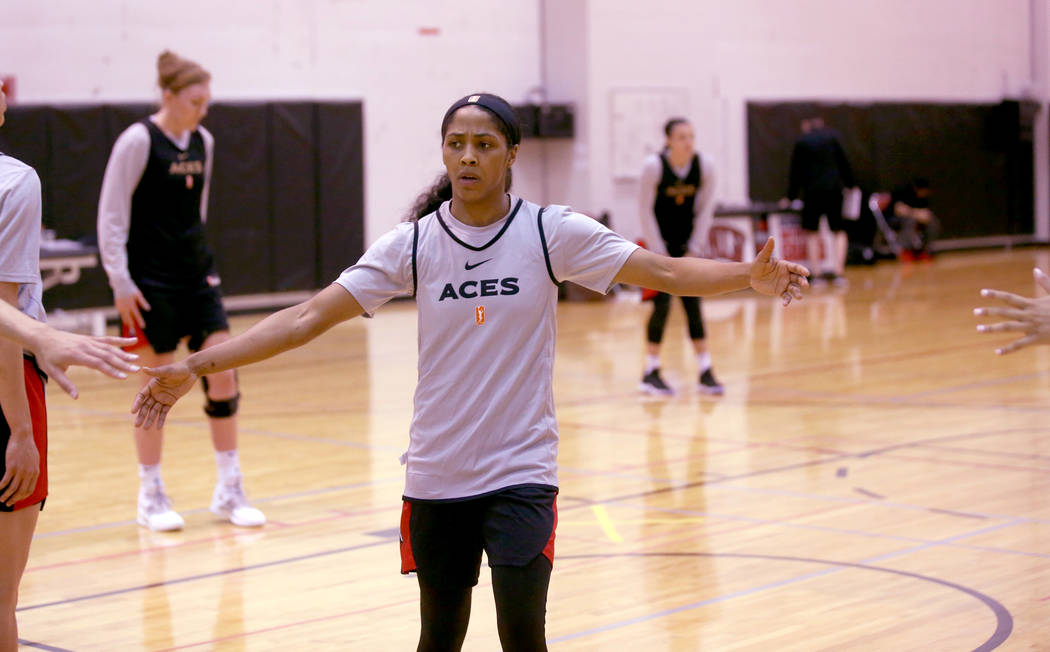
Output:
[132, 93, 807, 650]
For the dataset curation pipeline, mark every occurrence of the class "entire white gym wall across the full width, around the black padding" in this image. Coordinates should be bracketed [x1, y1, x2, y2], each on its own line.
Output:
[0, 0, 1050, 251]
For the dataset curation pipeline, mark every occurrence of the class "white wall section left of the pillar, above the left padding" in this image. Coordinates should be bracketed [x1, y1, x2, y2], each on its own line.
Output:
[0, 0, 540, 248]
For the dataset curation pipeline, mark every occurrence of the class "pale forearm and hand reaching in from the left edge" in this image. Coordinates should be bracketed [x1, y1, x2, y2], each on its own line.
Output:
[0, 301, 139, 398]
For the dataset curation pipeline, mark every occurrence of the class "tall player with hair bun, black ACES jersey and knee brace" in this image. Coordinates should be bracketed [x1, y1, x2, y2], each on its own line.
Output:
[99, 51, 266, 531]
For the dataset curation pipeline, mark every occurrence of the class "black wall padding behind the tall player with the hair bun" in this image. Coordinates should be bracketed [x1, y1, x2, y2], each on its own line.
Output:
[0, 102, 364, 310]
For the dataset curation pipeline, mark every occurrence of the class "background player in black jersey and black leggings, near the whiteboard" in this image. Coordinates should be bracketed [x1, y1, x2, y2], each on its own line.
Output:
[638, 118, 725, 395]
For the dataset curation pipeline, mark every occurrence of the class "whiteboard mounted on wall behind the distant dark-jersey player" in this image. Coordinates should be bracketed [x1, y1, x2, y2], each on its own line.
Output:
[609, 88, 689, 180]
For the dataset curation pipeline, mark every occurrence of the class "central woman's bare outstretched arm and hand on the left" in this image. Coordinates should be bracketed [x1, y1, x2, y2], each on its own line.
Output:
[131, 283, 363, 427]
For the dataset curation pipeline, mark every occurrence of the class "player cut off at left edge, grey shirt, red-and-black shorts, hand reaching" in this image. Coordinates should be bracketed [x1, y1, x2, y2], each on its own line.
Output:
[0, 85, 138, 652]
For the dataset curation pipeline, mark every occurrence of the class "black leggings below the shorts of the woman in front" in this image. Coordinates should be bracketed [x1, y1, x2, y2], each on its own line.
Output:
[417, 554, 551, 652]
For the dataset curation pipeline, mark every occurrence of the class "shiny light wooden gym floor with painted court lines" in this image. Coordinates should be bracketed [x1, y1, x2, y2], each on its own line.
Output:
[18, 249, 1050, 651]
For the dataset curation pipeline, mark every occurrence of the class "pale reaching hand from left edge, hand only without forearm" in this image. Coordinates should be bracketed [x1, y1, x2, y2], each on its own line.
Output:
[30, 329, 139, 398]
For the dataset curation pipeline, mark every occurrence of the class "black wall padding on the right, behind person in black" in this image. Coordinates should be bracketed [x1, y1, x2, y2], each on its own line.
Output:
[748, 103, 1034, 238]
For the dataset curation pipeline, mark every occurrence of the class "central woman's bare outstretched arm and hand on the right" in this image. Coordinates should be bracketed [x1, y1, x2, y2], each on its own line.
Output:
[614, 238, 810, 306]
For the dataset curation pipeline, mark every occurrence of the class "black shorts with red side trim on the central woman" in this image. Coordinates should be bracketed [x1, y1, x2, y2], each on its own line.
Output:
[401, 485, 558, 589]
